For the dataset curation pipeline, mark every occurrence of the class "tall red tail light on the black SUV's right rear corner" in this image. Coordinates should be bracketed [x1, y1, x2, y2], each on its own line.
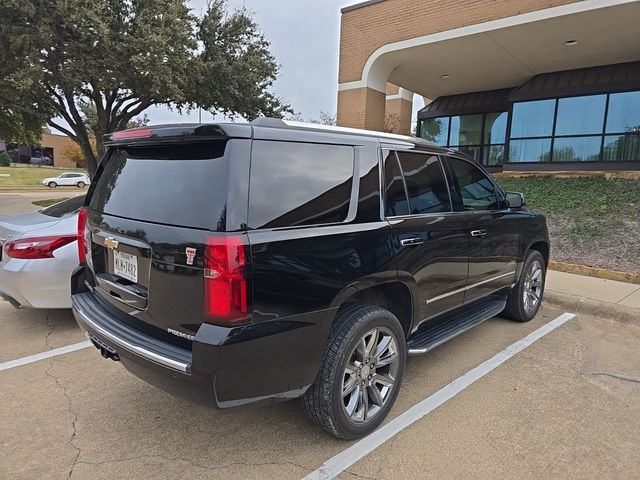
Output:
[204, 235, 247, 325]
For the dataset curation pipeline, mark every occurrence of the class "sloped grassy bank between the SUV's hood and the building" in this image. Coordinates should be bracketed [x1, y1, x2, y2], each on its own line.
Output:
[498, 176, 640, 274]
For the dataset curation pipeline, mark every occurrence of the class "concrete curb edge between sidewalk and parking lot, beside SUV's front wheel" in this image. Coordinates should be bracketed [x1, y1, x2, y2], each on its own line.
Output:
[544, 290, 640, 323]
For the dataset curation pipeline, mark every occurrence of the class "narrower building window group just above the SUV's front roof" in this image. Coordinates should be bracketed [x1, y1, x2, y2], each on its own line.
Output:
[419, 112, 507, 165]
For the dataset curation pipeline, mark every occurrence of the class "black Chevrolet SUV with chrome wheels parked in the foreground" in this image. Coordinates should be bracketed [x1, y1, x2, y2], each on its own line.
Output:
[72, 119, 549, 439]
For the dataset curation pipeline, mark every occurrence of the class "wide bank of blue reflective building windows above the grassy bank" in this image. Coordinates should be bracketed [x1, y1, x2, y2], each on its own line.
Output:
[509, 92, 640, 163]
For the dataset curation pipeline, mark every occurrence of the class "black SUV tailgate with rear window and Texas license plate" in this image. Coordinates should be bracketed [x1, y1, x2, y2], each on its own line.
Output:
[81, 140, 239, 335]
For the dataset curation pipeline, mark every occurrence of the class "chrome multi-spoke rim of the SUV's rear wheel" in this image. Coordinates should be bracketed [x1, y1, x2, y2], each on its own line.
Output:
[342, 327, 400, 423]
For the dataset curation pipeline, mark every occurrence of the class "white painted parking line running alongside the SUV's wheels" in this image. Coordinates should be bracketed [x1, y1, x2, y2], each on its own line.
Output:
[305, 313, 575, 480]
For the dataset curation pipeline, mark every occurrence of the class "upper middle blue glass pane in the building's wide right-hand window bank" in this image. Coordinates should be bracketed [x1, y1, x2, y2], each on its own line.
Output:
[556, 95, 607, 135]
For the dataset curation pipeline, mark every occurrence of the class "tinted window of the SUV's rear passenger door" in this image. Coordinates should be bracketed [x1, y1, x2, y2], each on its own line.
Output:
[385, 152, 451, 216]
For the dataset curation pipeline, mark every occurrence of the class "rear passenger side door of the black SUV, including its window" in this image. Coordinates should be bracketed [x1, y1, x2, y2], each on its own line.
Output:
[384, 151, 469, 326]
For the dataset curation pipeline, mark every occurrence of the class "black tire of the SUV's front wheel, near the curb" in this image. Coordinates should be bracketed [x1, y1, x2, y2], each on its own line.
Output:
[502, 250, 547, 322]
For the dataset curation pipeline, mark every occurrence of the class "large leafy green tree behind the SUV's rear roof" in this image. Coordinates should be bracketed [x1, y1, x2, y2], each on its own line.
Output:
[0, 0, 291, 174]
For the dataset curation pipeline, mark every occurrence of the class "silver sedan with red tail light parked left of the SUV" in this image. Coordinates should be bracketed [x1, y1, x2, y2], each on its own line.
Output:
[0, 195, 84, 308]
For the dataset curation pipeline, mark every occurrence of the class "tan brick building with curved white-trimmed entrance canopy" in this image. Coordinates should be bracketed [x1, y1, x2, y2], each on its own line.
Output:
[337, 0, 640, 170]
